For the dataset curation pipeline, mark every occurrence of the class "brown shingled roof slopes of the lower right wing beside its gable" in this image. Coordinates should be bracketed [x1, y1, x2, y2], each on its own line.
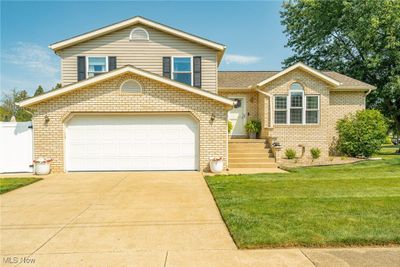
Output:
[218, 64, 376, 90]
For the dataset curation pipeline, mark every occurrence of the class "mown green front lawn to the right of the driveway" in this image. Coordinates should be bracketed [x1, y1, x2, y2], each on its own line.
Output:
[206, 146, 400, 248]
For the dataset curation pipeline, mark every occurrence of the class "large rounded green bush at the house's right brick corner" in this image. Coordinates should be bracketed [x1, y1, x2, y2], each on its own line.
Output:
[336, 110, 387, 157]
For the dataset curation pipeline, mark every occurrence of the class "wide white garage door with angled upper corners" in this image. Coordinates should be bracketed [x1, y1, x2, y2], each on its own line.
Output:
[66, 115, 199, 171]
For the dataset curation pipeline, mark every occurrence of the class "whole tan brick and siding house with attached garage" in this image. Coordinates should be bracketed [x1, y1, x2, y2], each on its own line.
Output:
[19, 17, 375, 171]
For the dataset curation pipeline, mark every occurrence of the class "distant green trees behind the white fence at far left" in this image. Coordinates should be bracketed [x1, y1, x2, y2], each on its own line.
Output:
[1, 89, 32, 121]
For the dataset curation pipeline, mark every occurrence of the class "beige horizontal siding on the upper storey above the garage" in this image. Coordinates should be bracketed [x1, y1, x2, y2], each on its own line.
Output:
[58, 25, 217, 93]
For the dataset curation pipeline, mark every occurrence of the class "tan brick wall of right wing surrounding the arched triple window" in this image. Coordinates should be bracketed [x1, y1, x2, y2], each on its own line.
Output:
[259, 70, 365, 160]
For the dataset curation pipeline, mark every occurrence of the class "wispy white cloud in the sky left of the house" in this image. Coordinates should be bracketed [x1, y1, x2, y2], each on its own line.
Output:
[2, 42, 59, 75]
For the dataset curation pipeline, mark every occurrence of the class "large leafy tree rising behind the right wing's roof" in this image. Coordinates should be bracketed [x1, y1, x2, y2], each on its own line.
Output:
[281, 0, 400, 147]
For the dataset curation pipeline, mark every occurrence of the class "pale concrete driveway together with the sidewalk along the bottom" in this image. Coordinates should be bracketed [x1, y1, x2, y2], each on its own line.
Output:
[0, 172, 400, 267]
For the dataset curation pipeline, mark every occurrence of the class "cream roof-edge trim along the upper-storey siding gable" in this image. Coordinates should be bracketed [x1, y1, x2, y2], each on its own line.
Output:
[49, 16, 226, 54]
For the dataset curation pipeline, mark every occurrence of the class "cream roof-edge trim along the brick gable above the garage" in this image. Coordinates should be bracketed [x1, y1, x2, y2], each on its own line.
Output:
[17, 65, 233, 107]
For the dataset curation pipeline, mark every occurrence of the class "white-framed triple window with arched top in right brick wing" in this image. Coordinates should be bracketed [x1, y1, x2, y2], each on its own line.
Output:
[274, 83, 320, 124]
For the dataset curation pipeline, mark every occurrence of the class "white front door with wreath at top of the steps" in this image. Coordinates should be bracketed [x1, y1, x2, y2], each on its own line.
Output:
[228, 97, 247, 135]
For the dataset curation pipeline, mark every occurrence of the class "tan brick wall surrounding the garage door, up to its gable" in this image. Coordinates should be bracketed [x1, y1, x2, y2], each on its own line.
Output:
[32, 74, 227, 172]
